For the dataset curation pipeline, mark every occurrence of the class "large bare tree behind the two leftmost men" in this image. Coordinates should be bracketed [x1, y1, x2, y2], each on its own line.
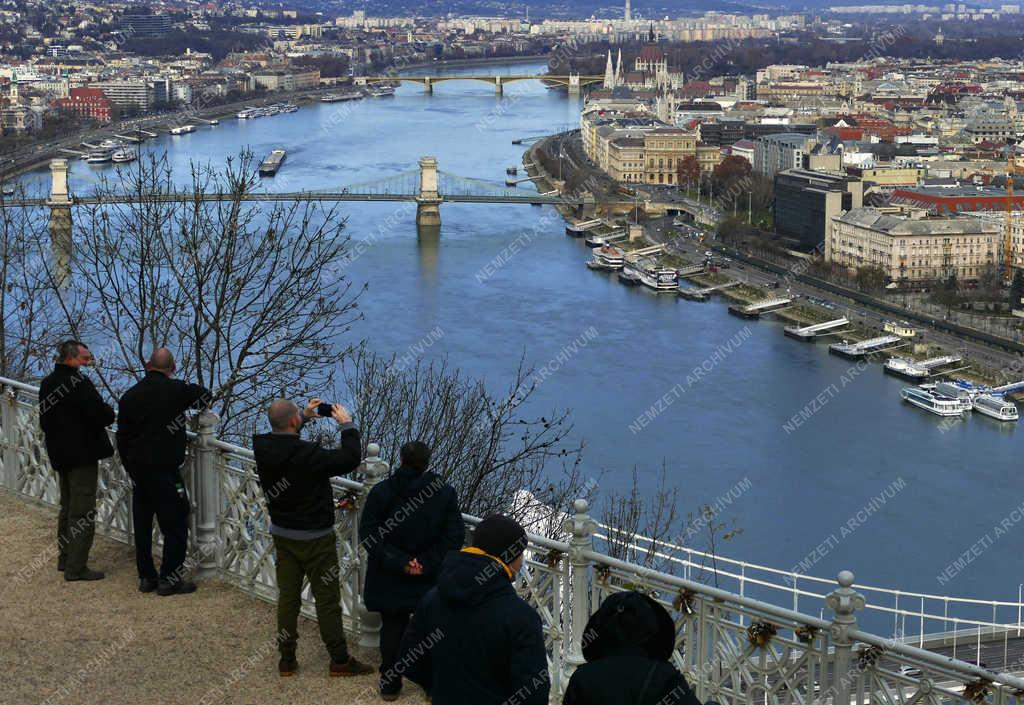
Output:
[44, 153, 359, 440]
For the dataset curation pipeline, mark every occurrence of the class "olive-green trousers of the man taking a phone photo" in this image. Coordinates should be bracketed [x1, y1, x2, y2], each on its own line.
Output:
[273, 531, 348, 663]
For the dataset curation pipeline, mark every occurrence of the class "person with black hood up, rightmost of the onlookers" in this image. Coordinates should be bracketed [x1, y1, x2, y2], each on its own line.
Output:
[562, 591, 700, 705]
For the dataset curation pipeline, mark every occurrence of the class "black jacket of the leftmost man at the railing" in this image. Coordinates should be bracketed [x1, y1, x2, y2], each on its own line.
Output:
[39, 363, 114, 472]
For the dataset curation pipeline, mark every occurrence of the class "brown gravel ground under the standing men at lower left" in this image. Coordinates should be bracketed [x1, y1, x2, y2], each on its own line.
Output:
[0, 494, 425, 705]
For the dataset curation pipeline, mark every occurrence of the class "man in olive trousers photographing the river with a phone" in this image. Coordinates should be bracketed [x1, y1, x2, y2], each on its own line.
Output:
[253, 399, 373, 676]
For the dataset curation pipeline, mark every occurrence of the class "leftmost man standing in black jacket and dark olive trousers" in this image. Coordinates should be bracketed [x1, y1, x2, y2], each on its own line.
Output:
[39, 340, 115, 581]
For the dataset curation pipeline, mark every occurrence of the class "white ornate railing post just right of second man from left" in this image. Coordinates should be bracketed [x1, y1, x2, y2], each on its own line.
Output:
[193, 411, 220, 576]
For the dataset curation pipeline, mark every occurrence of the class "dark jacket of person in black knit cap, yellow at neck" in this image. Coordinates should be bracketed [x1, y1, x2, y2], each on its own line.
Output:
[398, 551, 551, 705]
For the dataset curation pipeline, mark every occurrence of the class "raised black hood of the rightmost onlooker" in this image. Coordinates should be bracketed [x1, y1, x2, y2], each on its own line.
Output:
[583, 591, 676, 661]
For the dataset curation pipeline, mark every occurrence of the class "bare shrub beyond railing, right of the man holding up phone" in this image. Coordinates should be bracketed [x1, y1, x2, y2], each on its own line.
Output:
[344, 348, 586, 533]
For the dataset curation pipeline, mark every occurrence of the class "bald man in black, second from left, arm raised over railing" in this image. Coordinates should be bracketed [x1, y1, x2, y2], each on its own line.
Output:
[117, 347, 211, 596]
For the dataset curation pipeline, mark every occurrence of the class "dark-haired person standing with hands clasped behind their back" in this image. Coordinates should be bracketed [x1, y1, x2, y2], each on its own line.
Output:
[359, 441, 465, 701]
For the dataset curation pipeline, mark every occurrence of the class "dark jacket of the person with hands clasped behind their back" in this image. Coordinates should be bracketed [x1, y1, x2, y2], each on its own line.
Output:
[359, 467, 465, 613]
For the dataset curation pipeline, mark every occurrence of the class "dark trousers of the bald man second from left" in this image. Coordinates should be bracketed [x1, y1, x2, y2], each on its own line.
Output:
[131, 468, 189, 582]
